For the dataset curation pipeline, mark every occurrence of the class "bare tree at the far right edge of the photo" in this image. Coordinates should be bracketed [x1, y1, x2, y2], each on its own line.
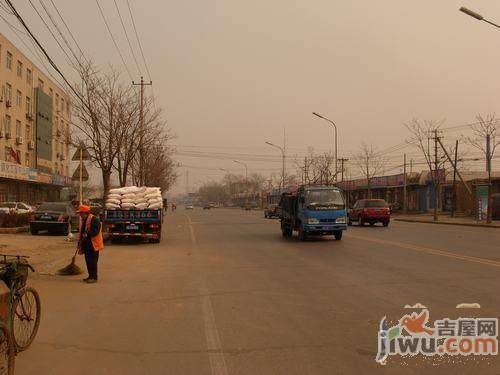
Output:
[466, 113, 500, 223]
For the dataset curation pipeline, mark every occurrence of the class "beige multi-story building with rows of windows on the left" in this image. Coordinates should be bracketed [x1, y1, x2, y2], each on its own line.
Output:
[0, 34, 71, 203]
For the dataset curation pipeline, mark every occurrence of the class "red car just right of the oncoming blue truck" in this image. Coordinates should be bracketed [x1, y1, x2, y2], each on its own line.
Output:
[348, 199, 391, 227]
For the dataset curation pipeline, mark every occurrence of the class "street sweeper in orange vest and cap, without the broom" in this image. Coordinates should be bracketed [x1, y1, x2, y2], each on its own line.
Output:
[76, 205, 104, 284]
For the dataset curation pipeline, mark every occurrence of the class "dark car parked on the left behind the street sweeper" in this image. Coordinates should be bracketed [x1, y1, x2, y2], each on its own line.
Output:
[30, 202, 78, 235]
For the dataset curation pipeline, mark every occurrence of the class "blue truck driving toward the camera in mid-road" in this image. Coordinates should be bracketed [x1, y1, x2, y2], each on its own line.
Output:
[280, 185, 347, 241]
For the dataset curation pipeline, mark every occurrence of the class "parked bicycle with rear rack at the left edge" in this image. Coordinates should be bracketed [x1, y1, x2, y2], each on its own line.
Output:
[0, 254, 41, 356]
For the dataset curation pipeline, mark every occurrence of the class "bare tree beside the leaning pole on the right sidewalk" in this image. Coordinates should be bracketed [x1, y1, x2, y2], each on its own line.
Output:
[405, 119, 445, 221]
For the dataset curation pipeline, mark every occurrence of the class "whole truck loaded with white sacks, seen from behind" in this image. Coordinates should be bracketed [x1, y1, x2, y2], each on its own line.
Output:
[102, 186, 163, 243]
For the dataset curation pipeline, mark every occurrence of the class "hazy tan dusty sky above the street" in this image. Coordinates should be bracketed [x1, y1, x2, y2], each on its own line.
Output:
[0, 0, 500, 192]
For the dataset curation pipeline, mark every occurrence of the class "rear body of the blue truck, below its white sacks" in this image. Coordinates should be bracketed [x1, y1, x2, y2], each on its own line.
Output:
[103, 208, 163, 243]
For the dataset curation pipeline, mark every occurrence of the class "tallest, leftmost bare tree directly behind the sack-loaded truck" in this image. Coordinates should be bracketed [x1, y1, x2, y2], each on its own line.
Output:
[73, 63, 137, 200]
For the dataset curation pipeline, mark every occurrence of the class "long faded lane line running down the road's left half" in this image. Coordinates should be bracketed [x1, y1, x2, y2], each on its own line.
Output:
[185, 215, 229, 375]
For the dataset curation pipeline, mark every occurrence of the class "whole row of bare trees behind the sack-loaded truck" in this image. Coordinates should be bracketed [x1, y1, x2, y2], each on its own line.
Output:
[71, 63, 177, 196]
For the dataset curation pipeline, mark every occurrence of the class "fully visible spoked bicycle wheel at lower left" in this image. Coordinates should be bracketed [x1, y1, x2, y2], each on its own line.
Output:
[12, 286, 41, 352]
